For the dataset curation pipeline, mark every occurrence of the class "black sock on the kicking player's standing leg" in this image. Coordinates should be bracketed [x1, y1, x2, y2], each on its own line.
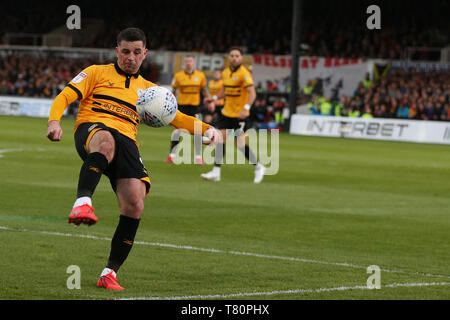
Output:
[106, 215, 141, 273]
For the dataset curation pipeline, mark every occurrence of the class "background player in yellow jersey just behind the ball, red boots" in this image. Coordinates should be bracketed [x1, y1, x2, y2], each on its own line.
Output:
[165, 55, 209, 164]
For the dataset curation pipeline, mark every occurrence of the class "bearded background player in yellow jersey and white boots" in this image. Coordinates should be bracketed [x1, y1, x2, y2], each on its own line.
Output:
[201, 47, 266, 183]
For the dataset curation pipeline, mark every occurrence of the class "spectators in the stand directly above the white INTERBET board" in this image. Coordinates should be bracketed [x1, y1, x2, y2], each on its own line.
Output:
[308, 69, 450, 121]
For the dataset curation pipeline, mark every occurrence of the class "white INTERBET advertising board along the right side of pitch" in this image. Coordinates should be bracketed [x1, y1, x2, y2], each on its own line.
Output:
[290, 114, 450, 144]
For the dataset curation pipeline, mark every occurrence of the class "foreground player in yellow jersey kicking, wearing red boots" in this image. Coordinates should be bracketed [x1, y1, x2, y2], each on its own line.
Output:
[47, 28, 218, 290]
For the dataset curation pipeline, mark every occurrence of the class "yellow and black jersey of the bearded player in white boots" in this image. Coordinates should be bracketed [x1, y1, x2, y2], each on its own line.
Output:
[222, 65, 253, 118]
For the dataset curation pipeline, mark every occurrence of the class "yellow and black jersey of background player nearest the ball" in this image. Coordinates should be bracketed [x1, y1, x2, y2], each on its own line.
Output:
[172, 70, 206, 106]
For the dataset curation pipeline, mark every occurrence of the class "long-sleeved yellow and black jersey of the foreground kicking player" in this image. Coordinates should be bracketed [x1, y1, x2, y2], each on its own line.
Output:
[49, 62, 208, 141]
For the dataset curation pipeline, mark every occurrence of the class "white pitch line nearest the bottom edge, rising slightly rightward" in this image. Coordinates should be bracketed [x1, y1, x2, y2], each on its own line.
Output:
[118, 282, 450, 300]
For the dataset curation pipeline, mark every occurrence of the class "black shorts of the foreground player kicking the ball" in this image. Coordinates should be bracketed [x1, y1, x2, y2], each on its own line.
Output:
[74, 122, 151, 193]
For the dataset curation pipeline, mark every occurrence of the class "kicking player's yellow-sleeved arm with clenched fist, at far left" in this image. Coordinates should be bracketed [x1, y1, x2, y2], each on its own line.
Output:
[47, 87, 78, 141]
